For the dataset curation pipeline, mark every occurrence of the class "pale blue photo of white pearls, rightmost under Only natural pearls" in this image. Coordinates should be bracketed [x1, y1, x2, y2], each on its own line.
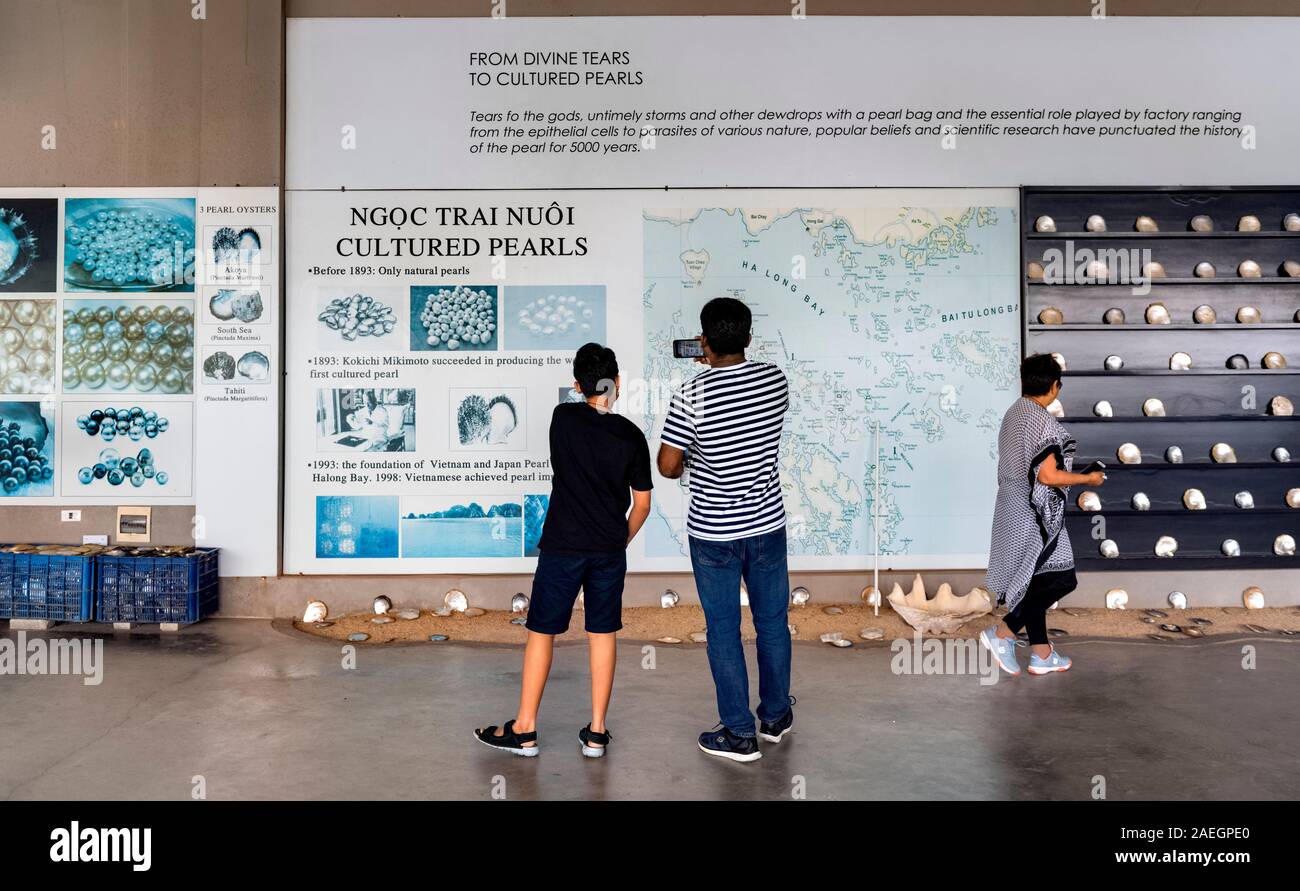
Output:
[502, 285, 606, 351]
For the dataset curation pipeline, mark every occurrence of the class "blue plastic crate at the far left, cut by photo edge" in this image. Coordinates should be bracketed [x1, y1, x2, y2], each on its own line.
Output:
[0, 552, 95, 622]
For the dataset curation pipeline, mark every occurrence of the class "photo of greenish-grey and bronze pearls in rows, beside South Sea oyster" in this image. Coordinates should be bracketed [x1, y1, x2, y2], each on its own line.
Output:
[62, 299, 194, 394]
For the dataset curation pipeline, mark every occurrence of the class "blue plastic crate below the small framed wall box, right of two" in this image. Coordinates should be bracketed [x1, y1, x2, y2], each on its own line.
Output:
[95, 548, 220, 624]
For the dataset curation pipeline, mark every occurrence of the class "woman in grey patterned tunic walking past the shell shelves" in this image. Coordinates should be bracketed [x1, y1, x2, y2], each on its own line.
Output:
[980, 354, 1105, 675]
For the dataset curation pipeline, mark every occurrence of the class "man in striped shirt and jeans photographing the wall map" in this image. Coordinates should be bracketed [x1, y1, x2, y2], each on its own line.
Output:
[659, 297, 794, 761]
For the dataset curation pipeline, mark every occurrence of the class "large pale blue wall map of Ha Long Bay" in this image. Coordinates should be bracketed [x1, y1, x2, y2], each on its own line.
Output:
[644, 197, 1021, 568]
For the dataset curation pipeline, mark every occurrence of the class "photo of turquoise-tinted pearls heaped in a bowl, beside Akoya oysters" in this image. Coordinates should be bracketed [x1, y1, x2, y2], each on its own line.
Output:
[64, 198, 195, 291]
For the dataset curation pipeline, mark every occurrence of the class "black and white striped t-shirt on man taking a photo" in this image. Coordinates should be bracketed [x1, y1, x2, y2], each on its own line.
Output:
[663, 362, 789, 541]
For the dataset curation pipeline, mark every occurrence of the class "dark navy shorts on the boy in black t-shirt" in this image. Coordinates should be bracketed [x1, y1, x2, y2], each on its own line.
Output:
[524, 550, 628, 635]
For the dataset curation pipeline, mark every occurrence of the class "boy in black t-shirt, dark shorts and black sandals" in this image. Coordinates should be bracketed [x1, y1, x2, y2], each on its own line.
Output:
[475, 343, 653, 758]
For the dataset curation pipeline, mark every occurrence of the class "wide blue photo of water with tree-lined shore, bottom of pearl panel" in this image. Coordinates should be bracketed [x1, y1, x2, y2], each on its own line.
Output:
[402, 496, 524, 557]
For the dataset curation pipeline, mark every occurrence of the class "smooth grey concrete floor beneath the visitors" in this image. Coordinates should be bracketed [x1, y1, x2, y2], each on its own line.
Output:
[0, 619, 1300, 800]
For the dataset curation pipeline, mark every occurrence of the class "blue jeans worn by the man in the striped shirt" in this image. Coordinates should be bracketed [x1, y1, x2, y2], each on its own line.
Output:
[690, 528, 790, 736]
